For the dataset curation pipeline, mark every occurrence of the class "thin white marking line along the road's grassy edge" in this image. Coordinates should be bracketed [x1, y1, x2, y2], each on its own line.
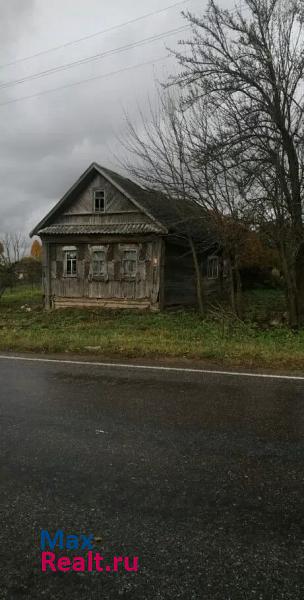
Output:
[0, 354, 304, 381]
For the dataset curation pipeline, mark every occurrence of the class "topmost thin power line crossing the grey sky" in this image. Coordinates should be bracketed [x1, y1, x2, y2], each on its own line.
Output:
[0, 0, 190, 69]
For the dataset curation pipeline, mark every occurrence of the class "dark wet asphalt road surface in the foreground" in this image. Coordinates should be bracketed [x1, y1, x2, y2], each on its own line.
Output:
[0, 358, 304, 600]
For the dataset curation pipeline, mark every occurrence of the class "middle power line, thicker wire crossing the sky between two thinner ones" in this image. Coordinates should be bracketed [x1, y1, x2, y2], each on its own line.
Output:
[0, 25, 190, 89]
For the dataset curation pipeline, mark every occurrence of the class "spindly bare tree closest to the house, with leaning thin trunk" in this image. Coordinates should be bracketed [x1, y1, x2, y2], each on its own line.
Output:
[124, 93, 215, 314]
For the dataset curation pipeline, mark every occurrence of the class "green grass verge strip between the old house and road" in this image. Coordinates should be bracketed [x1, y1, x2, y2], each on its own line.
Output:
[0, 287, 304, 370]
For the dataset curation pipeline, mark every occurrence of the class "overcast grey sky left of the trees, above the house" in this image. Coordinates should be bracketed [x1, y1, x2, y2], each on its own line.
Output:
[0, 0, 233, 235]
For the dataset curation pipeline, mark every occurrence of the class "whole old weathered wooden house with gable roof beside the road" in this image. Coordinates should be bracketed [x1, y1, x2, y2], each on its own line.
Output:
[31, 163, 219, 310]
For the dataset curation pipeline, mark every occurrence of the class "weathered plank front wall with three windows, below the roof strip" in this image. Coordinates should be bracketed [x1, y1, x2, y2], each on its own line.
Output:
[43, 236, 162, 309]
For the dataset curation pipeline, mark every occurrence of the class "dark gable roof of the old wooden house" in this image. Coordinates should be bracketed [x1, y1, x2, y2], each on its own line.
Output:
[30, 163, 213, 245]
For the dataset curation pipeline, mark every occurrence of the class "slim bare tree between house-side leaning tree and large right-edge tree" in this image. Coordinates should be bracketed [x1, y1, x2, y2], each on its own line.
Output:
[187, 100, 254, 317]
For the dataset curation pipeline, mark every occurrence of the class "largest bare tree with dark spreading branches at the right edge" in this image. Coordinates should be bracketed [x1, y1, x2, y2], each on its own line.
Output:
[174, 0, 304, 327]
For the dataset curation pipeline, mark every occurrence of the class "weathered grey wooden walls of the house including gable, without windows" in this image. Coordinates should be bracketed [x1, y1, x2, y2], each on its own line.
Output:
[42, 168, 219, 310]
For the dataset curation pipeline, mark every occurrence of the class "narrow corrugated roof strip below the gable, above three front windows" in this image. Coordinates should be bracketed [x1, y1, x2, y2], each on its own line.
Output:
[38, 223, 162, 235]
